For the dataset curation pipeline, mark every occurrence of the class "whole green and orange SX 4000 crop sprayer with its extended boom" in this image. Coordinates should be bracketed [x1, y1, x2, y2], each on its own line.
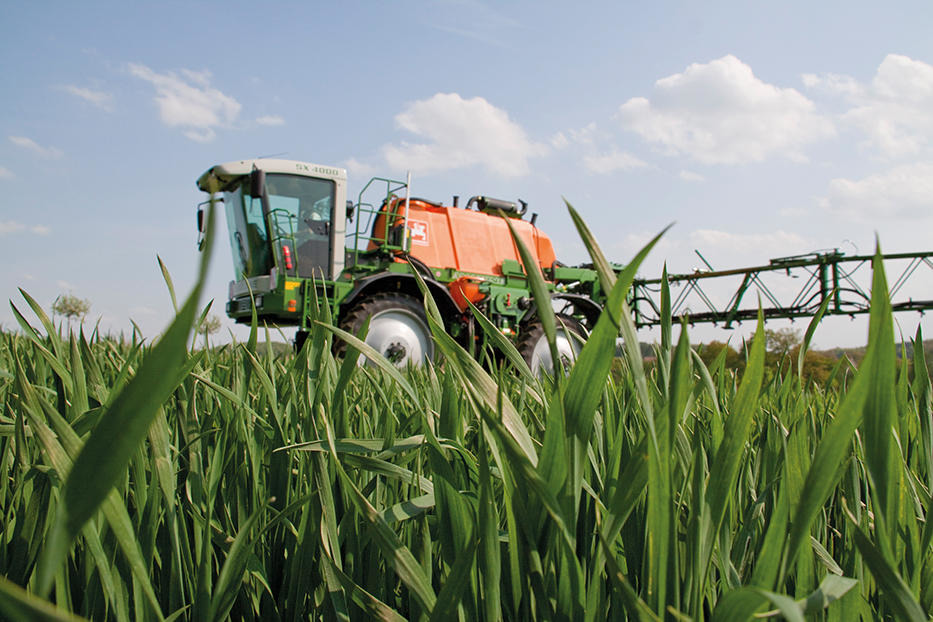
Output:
[197, 159, 933, 372]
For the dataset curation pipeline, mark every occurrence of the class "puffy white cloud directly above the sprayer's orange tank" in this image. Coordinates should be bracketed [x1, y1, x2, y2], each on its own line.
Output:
[382, 93, 547, 177]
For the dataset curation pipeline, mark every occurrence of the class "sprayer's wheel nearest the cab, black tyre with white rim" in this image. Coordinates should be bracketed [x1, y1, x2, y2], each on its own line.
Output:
[340, 292, 434, 368]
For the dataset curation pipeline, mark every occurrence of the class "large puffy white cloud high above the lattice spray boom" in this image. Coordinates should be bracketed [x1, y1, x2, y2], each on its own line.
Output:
[617, 55, 834, 164]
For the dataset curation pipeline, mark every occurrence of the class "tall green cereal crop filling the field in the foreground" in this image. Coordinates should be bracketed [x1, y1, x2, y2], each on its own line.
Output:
[0, 212, 933, 620]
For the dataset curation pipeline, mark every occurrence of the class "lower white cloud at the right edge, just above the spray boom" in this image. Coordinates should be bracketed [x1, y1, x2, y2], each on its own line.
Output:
[820, 162, 933, 223]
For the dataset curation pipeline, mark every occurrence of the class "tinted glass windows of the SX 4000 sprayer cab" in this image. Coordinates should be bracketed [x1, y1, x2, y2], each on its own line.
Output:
[224, 173, 335, 278]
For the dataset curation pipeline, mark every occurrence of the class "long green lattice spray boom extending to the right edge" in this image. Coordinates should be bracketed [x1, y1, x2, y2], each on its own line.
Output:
[632, 250, 933, 328]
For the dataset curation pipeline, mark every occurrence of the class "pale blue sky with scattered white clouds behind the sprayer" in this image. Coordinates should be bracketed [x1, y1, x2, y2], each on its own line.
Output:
[0, 0, 933, 347]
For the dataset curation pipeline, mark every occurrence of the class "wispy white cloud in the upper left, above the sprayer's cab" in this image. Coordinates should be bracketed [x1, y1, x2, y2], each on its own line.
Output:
[129, 64, 241, 142]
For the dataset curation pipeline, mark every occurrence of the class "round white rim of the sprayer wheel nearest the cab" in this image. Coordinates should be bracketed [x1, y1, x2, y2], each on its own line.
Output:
[366, 309, 434, 368]
